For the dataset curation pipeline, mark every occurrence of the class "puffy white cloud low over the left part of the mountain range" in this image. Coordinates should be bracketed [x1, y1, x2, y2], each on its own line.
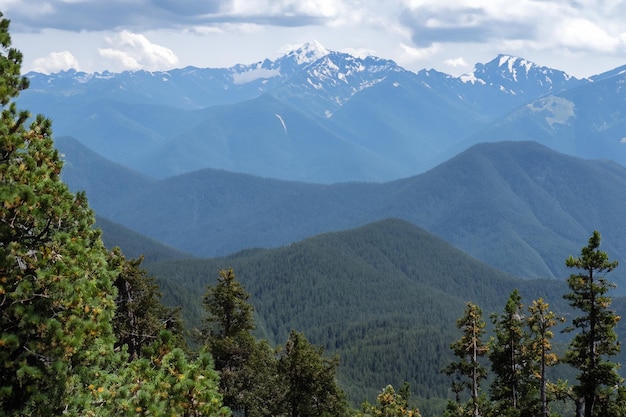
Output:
[98, 30, 178, 71]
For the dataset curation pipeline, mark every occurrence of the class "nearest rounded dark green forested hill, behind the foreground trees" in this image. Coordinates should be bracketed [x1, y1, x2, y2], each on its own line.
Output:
[147, 219, 576, 405]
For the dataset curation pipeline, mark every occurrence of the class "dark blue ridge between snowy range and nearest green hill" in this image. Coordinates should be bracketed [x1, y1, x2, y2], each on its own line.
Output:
[61, 138, 626, 288]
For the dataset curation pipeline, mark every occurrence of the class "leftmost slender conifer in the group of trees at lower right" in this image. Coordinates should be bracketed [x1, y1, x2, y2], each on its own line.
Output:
[443, 302, 489, 417]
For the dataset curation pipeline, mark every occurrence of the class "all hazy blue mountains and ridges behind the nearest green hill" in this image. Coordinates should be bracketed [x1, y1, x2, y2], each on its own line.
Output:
[19, 43, 626, 288]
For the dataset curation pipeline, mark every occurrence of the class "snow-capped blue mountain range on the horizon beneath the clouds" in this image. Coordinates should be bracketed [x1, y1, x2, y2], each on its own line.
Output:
[20, 43, 626, 183]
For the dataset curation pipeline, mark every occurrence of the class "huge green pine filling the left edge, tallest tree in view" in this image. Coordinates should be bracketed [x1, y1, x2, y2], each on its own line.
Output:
[0, 14, 115, 416]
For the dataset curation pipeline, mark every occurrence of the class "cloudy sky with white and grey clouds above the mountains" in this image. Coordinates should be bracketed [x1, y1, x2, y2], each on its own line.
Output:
[0, 0, 626, 77]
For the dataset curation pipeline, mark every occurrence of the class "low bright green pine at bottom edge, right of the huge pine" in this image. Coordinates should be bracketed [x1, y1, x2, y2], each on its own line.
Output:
[98, 330, 230, 417]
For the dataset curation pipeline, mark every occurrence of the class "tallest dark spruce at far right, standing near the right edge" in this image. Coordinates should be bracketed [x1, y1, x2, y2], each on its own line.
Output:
[564, 231, 622, 417]
